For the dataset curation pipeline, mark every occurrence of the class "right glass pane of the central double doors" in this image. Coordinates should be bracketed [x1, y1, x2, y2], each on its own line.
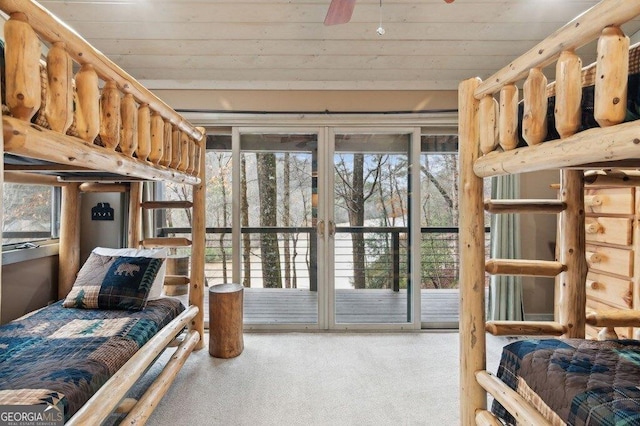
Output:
[329, 134, 412, 324]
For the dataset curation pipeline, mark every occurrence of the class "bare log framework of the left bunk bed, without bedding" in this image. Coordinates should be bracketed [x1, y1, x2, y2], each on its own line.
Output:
[0, 0, 205, 425]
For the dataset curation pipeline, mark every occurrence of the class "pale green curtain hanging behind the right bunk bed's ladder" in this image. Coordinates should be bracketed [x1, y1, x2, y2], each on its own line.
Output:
[488, 175, 524, 321]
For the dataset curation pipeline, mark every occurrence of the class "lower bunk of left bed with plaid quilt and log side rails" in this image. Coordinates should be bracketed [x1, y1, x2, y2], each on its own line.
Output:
[0, 298, 200, 424]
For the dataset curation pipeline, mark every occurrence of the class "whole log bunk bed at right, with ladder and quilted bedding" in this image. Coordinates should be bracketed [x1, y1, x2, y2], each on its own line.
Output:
[459, 0, 640, 425]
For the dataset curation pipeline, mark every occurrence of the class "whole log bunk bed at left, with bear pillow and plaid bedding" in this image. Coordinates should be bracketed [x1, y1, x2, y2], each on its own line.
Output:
[0, 0, 205, 425]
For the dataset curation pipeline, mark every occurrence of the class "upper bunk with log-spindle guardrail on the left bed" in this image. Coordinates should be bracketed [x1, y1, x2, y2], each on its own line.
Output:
[0, 0, 204, 185]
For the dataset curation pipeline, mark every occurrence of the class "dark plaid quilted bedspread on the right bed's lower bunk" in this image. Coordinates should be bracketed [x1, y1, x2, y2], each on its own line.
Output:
[492, 339, 640, 426]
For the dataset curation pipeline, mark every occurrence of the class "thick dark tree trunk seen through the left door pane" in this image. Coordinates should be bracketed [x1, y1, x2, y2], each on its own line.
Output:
[257, 153, 282, 288]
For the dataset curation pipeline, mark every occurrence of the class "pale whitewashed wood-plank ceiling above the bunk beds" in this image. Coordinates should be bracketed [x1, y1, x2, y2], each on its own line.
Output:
[40, 0, 640, 90]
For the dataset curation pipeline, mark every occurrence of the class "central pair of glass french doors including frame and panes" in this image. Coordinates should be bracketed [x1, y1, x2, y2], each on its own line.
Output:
[232, 127, 420, 329]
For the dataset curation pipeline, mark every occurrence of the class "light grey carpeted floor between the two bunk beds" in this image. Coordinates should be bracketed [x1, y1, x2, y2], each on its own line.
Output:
[114, 332, 506, 426]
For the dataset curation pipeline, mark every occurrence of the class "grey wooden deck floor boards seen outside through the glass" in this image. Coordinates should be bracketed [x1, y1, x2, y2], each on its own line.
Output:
[183, 288, 459, 328]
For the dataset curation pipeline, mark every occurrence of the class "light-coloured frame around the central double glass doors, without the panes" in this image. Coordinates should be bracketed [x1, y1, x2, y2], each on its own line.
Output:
[231, 125, 421, 331]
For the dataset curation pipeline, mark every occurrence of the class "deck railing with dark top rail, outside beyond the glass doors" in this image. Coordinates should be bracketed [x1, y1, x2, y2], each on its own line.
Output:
[157, 227, 489, 291]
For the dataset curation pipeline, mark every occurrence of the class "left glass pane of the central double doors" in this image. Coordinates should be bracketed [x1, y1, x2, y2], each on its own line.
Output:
[239, 133, 318, 324]
